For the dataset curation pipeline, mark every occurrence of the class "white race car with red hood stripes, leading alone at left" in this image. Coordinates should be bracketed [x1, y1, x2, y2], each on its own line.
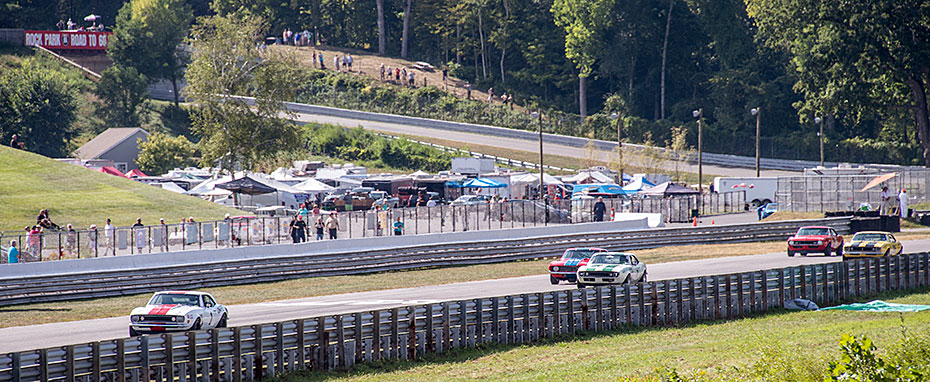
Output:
[129, 291, 229, 337]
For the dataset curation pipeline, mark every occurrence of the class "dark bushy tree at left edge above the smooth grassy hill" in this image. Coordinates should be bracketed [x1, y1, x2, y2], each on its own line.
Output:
[0, 60, 77, 158]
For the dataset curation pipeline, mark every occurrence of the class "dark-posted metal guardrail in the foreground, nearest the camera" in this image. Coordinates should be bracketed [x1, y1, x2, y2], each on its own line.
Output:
[0, 253, 930, 382]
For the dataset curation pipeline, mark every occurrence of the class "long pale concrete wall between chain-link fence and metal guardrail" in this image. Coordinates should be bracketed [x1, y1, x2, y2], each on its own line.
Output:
[0, 219, 648, 280]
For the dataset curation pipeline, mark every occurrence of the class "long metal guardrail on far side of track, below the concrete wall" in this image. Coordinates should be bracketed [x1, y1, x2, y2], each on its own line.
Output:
[0, 217, 850, 306]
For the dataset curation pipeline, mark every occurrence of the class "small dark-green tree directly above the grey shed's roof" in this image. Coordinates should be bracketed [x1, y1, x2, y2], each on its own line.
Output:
[95, 65, 148, 126]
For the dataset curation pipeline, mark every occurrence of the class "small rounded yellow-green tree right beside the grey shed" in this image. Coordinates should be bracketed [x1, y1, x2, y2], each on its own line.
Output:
[136, 132, 195, 175]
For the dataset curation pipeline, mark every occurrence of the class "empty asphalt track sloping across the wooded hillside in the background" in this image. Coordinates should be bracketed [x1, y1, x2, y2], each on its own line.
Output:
[295, 113, 798, 178]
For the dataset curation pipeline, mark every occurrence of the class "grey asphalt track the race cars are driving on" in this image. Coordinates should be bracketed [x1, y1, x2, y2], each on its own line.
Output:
[0, 240, 930, 353]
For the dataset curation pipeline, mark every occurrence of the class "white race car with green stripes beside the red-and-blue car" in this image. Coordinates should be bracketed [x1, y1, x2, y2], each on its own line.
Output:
[577, 252, 646, 288]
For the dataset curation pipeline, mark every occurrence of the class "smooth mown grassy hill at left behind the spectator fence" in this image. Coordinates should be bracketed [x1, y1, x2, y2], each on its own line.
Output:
[0, 147, 242, 231]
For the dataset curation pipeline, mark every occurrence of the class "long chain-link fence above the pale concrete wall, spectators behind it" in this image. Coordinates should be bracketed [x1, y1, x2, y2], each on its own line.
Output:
[0, 192, 745, 266]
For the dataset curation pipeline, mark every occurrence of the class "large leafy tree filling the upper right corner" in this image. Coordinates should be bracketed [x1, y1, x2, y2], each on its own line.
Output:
[747, 0, 930, 166]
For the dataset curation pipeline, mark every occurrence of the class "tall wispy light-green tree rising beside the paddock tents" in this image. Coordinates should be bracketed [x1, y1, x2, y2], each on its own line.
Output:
[185, 14, 300, 175]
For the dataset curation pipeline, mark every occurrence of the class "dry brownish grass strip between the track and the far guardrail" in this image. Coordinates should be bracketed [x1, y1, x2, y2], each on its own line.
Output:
[0, 242, 785, 327]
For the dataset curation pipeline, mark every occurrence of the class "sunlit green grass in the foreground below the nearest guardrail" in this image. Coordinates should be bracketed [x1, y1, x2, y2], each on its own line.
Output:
[278, 290, 930, 382]
